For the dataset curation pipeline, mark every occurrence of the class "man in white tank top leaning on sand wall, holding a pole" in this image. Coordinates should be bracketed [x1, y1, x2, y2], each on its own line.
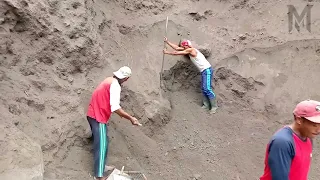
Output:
[163, 37, 218, 113]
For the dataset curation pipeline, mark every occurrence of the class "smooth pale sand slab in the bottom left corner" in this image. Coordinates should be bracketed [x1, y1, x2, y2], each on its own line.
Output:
[0, 125, 44, 180]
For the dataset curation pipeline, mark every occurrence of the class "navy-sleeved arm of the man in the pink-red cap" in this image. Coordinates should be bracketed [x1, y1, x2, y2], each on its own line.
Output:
[268, 138, 294, 180]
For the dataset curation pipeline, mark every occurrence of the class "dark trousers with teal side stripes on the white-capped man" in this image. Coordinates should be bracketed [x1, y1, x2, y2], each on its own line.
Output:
[87, 116, 109, 177]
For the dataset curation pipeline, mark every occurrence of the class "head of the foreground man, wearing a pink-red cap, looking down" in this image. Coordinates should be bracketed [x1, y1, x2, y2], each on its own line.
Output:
[293, 100, 320, 138]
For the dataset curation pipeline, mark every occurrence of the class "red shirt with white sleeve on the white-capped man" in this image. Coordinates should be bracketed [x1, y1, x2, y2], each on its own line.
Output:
[87, 77, 121, 124]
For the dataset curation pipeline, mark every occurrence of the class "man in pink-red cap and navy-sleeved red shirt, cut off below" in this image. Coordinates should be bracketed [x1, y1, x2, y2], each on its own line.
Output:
[260, 100, 320, 180]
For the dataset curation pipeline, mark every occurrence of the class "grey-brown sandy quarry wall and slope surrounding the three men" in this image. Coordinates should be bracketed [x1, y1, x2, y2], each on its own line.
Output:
[0, 0, 320, 180]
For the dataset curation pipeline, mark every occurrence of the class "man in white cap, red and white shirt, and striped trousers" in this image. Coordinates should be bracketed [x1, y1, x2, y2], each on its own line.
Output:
[87, 66, 141, 180]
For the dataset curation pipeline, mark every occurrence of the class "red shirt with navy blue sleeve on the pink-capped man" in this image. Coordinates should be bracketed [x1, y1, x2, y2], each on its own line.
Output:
[260, 126, 312, 180]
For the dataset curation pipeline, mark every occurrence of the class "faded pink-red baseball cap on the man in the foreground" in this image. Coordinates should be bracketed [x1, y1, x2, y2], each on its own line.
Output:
[293, 100, 320, 123]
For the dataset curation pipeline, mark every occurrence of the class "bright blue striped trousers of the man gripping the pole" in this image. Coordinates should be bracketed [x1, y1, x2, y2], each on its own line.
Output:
[201, 67, 216, 100]
